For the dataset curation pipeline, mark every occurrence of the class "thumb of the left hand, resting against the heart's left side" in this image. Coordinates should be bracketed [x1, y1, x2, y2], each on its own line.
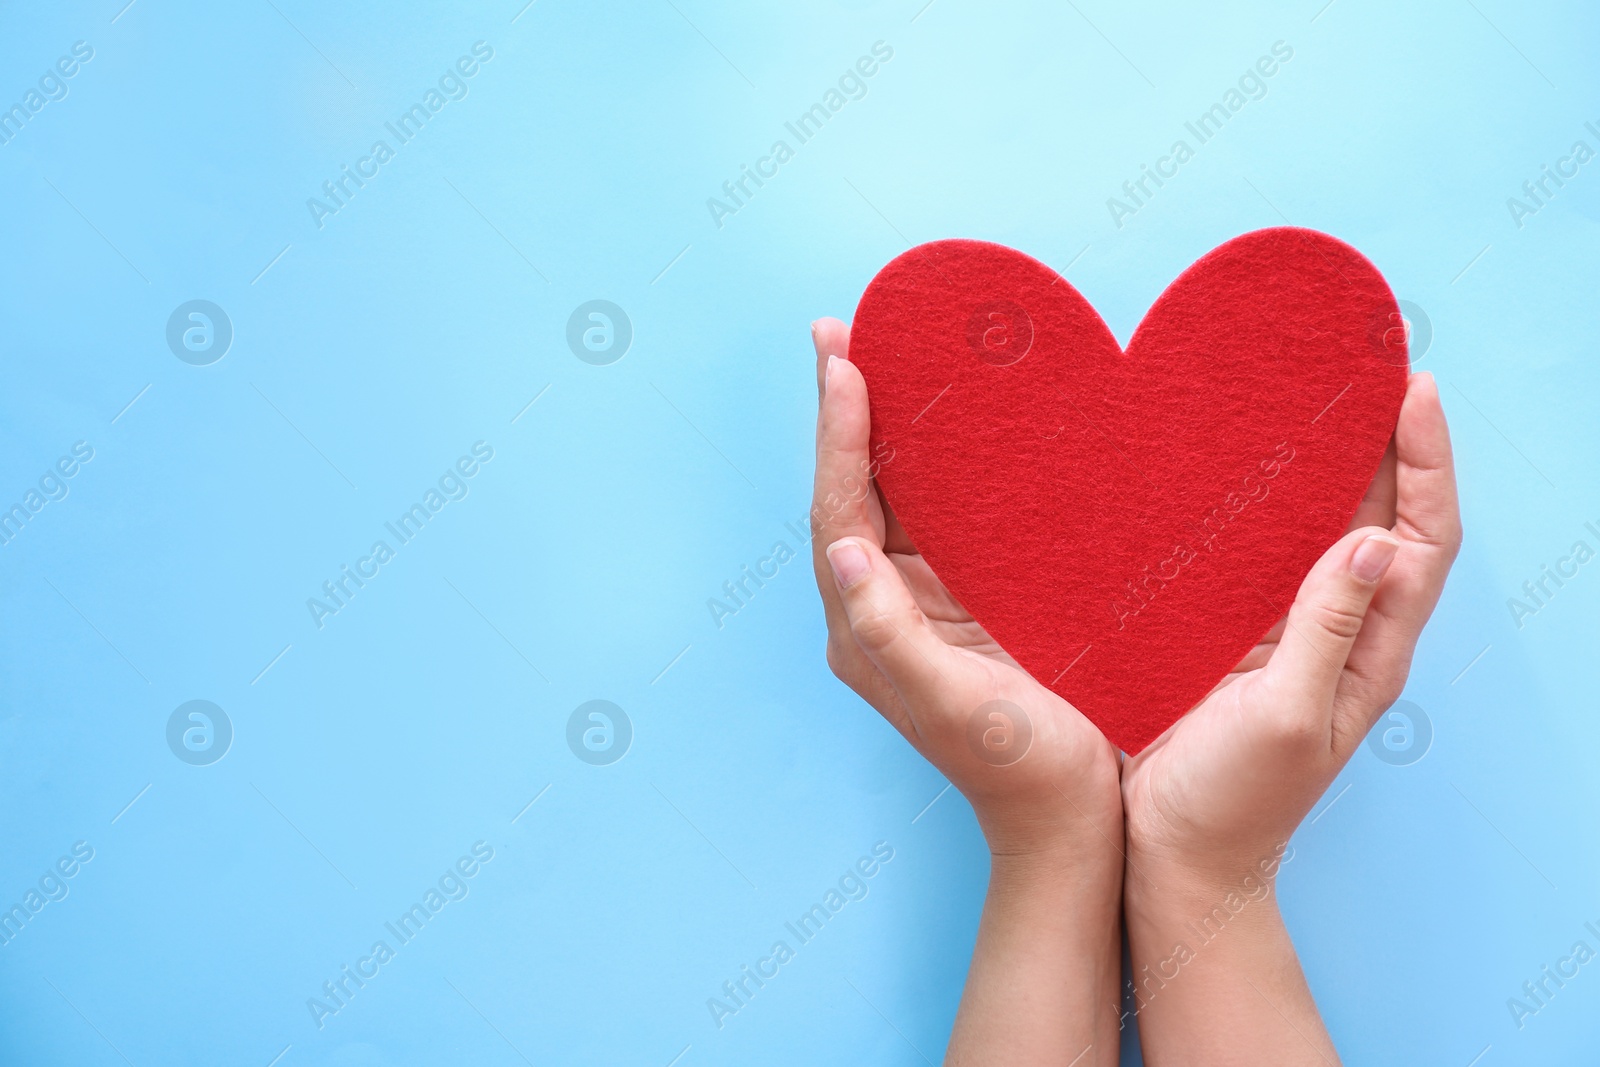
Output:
[827, 537, 952, 723]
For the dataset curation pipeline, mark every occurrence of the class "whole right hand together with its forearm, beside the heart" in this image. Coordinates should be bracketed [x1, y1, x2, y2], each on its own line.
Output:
[1122, 374, 1461, 1067]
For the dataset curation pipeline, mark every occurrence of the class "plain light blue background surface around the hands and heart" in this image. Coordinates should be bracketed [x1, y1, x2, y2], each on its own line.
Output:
[0, 0, 1600, 1067]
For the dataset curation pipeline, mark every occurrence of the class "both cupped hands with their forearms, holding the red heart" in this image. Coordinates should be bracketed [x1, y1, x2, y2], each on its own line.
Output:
[811, 318, 1461, 1067]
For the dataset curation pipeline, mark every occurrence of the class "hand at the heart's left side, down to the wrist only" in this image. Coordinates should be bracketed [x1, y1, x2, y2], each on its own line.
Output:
[811, 318, 1122, 867]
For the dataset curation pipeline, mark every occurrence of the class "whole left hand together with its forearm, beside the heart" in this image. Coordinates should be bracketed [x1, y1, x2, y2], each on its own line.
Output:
[811, 318, 1125, 1067]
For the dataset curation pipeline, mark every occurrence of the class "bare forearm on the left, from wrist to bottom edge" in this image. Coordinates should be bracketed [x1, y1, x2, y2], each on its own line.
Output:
[946, 843, 1122, 1067]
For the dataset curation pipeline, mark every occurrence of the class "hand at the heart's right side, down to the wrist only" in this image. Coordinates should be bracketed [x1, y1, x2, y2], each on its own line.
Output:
[1122, 373, 1461, 899]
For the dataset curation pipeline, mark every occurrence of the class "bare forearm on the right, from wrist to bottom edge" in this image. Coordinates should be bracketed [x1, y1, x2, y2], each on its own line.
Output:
[1125, 859, 1339, 1067]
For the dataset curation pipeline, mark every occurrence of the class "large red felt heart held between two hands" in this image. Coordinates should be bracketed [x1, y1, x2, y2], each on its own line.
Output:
[850, 227, 1408, 752]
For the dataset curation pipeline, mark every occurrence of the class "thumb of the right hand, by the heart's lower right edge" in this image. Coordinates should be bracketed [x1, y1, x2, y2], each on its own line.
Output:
[1264, 526, 1400, 736]
